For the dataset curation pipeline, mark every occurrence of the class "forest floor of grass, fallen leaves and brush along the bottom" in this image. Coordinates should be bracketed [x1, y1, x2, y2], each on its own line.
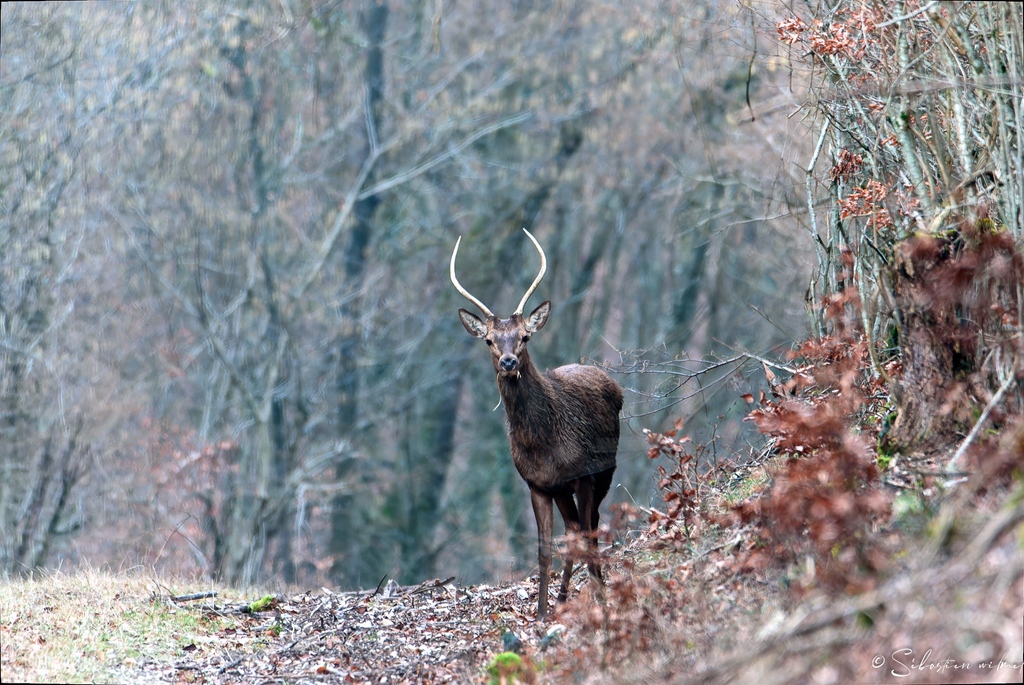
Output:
[0, 466, 1024, 685]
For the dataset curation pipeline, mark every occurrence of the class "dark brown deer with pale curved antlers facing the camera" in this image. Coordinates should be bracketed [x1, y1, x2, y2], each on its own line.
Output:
[450, 228, 623, 620]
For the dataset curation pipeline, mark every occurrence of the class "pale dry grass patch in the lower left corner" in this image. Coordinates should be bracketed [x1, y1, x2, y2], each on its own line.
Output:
[0, 570, 234, 683]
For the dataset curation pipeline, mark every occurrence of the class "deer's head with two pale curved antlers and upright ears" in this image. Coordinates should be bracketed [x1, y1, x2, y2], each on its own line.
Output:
[451, 228, 551, 378]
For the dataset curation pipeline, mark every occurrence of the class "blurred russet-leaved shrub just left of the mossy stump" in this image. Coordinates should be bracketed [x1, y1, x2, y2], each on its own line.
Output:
[725, 273, 891, 592]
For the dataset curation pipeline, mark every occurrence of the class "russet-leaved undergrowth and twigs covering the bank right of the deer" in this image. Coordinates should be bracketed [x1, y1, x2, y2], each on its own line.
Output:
[540, 225, 1024, 682]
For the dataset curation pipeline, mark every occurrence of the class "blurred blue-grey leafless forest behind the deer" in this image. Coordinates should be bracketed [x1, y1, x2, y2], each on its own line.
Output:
[0, 0, 1020, 587]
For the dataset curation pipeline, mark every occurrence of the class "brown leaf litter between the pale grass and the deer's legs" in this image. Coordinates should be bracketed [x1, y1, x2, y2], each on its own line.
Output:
[142, 574, 557, 683]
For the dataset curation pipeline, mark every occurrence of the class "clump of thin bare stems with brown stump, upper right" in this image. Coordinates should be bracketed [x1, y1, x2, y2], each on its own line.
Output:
[777, 2, 1024, 452]
